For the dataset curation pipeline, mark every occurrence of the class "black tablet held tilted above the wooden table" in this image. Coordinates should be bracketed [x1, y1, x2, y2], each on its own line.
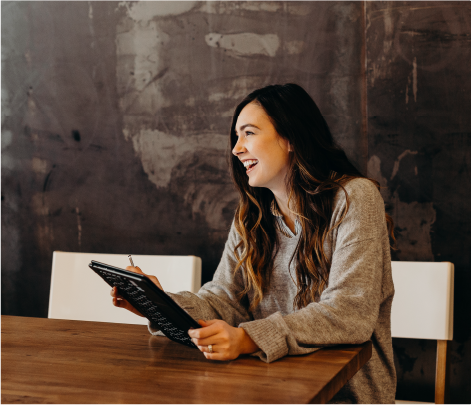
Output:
[88, 260, 201, 347]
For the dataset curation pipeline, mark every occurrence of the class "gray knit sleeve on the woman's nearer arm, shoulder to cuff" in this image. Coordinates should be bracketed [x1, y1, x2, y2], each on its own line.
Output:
[240, 179, 388, 362]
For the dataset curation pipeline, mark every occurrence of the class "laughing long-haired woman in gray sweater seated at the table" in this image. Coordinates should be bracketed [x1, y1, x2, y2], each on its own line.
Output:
[112, 84, 396, 405]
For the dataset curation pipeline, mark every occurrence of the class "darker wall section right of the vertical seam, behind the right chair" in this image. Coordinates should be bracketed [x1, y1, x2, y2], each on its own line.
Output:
[366, 0, 471, 404]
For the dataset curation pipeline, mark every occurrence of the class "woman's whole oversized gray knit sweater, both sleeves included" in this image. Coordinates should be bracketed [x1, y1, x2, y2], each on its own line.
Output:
[149, 179, 396, 405]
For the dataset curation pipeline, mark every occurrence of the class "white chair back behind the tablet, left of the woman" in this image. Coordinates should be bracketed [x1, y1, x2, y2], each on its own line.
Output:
[48, 252, 201, 325]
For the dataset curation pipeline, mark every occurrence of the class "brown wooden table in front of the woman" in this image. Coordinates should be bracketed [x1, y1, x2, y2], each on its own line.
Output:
[0, 316, 371, 405]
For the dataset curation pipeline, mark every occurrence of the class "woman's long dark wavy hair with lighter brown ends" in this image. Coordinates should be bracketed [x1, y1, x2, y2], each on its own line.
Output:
[230, 84, 394, 310]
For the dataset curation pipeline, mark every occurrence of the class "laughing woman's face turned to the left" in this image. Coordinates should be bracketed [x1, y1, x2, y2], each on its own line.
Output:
[232, 103, 290, 192]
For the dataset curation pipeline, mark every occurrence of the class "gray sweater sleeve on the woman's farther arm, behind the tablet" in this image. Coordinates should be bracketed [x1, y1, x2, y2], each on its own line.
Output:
[149, 224, 253, 335]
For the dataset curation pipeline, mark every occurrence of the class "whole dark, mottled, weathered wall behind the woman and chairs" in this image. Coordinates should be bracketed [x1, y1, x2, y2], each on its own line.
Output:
[0, 0, 471, 403]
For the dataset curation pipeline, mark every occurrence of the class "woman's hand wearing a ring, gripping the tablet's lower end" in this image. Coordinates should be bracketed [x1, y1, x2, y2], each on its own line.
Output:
[188, 319, 258, 360]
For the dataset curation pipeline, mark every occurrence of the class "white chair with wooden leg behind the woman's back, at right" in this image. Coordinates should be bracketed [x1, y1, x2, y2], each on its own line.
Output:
[391, 262, 454, 405]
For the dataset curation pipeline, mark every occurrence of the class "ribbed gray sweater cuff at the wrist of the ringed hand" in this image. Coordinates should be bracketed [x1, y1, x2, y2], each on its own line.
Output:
[239, 318, 288, 363]
